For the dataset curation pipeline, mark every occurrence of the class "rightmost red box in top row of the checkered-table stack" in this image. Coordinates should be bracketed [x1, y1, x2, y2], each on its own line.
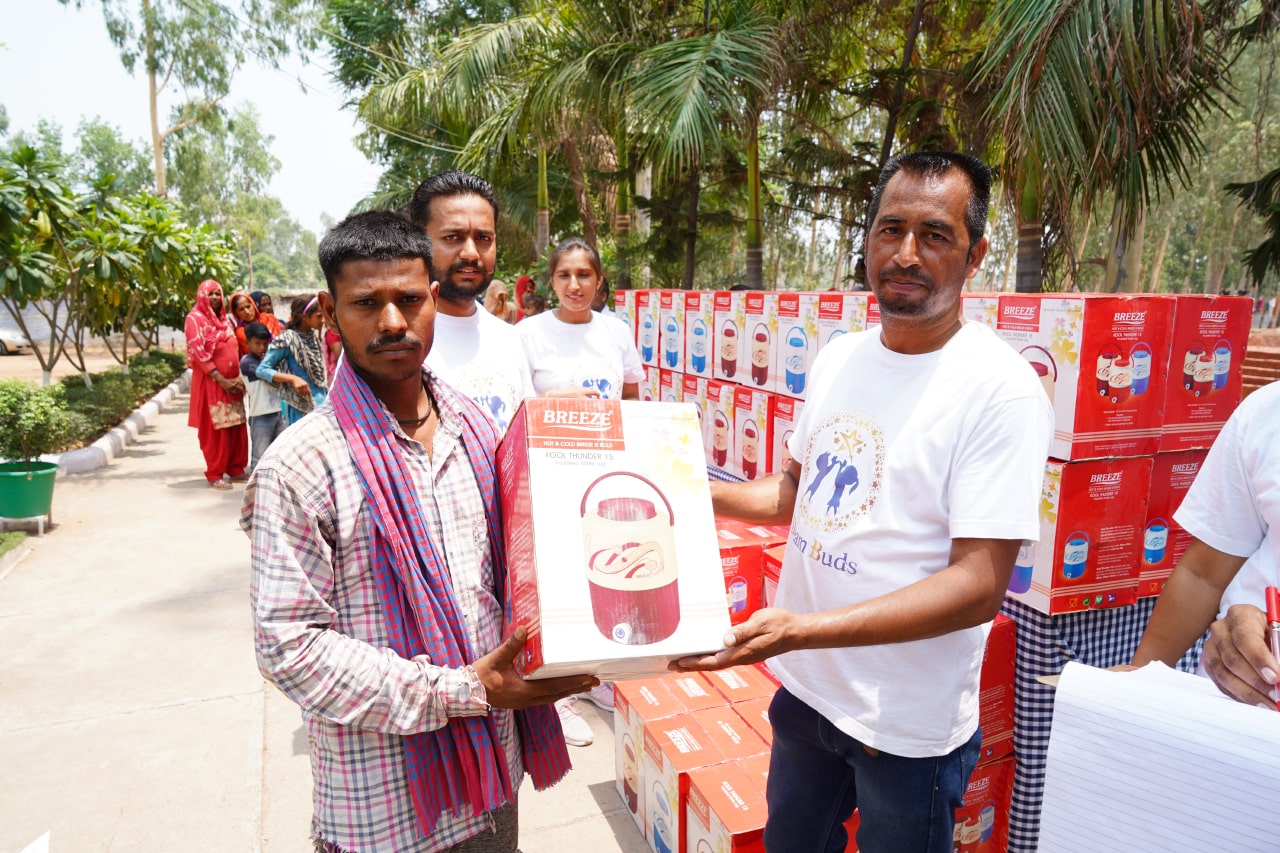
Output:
[1160, 296, 1253, 452]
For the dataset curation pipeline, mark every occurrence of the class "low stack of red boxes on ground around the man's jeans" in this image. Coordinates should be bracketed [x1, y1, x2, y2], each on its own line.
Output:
[613, 616, 1015, 853]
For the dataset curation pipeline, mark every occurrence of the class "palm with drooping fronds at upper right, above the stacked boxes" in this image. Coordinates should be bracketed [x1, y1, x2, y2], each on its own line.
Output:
[972, 0, 1280, 291]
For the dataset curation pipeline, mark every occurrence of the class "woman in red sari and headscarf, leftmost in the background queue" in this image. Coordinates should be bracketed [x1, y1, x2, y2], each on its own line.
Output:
[186, 279, 248, 489]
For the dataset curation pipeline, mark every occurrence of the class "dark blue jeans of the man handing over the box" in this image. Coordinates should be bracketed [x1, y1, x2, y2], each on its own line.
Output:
[764, 688, 982, 853]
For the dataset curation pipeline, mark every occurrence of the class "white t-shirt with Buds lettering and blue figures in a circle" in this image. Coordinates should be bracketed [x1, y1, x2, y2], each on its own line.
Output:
[771, 323, 1053, 757]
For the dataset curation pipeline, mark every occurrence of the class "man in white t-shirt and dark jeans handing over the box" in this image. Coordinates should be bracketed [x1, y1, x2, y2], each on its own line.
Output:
[675, 154, 1052, 853]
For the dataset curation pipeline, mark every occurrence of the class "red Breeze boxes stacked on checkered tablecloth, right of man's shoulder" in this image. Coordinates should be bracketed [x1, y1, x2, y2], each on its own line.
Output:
[964, 293, 1252, 615]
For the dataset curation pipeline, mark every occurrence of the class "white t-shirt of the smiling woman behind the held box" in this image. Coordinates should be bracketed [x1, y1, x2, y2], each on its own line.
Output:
[516, 311, 644, 400]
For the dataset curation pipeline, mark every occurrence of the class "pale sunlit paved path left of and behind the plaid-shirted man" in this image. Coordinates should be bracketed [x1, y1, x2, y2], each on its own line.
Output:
[0, 394, 648, 853]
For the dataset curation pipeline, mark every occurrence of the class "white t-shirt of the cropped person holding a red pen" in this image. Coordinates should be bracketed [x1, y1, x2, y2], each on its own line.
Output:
[1174, 382, 1280, 617]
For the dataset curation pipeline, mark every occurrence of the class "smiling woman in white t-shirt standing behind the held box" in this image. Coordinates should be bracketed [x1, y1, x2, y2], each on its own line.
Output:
[516, 237, 644, 400]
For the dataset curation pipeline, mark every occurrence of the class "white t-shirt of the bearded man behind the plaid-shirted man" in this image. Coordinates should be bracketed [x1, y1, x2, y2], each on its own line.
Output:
[426, 307, 534, 433]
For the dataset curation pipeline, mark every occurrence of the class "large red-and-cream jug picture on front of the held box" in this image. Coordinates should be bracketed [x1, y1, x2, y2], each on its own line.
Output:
[580, 471, 680, 646]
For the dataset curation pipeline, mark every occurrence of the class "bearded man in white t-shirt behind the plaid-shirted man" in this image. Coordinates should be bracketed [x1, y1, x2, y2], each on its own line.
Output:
[410, 172, 534, 432]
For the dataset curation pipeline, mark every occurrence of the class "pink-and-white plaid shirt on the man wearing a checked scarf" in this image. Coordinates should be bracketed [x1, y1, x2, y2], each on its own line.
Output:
[241, 371, 524, 853]
